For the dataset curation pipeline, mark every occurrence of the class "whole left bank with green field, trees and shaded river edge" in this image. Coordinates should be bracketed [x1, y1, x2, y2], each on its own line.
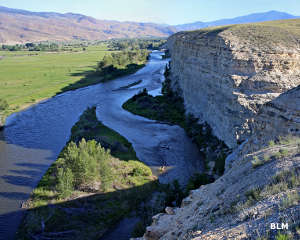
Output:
[0, 39, 165, 122]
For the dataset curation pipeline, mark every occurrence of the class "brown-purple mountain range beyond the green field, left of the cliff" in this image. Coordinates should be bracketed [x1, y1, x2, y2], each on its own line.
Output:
[0, 6, 176, 44]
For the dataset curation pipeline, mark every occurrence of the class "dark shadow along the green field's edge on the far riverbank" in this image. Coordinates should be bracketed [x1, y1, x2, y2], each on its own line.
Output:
[56, 64, 145, 95]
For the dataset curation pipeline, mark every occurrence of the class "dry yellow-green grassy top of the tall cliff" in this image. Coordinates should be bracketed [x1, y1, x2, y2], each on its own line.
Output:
[175, 19, 300, 50]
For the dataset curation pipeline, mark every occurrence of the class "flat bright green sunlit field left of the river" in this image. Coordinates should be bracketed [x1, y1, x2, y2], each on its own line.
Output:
[0, 44, 111, 115]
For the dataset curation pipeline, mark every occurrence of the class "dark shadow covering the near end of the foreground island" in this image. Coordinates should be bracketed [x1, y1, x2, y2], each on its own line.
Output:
[15, 180, 157, 240]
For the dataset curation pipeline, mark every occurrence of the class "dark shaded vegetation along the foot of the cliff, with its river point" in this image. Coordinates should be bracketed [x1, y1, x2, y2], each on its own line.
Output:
[123, 65, 229, 175]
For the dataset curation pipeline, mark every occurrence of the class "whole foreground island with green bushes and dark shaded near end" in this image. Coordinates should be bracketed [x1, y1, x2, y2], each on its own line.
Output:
[18, 108, 158, 239]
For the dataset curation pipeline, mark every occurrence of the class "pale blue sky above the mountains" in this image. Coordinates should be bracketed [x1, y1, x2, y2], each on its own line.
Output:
[0, 0, 300, 24]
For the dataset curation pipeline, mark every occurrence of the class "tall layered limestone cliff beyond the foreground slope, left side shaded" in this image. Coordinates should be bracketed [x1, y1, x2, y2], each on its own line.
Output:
[167, 24, 300, 147]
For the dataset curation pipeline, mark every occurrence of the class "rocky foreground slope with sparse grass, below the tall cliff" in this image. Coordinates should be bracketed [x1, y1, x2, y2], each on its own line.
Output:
[135, 87, 300, 240]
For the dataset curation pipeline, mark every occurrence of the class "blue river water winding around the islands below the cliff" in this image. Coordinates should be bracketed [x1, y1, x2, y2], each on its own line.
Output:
[0, 52, 202, 239]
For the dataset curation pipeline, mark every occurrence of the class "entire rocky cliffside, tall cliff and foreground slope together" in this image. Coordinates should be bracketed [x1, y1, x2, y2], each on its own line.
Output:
[135, 20, 300, 240]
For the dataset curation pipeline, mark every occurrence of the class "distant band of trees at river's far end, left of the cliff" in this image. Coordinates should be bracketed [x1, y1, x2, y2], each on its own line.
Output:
[108, 39, 166, 51]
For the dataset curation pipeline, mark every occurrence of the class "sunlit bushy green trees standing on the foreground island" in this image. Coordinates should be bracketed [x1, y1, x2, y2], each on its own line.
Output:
[56, 139, 112, 198]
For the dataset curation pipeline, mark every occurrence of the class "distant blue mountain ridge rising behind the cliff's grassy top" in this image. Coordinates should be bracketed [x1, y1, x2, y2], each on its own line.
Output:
[174, 11, 299, 31]
